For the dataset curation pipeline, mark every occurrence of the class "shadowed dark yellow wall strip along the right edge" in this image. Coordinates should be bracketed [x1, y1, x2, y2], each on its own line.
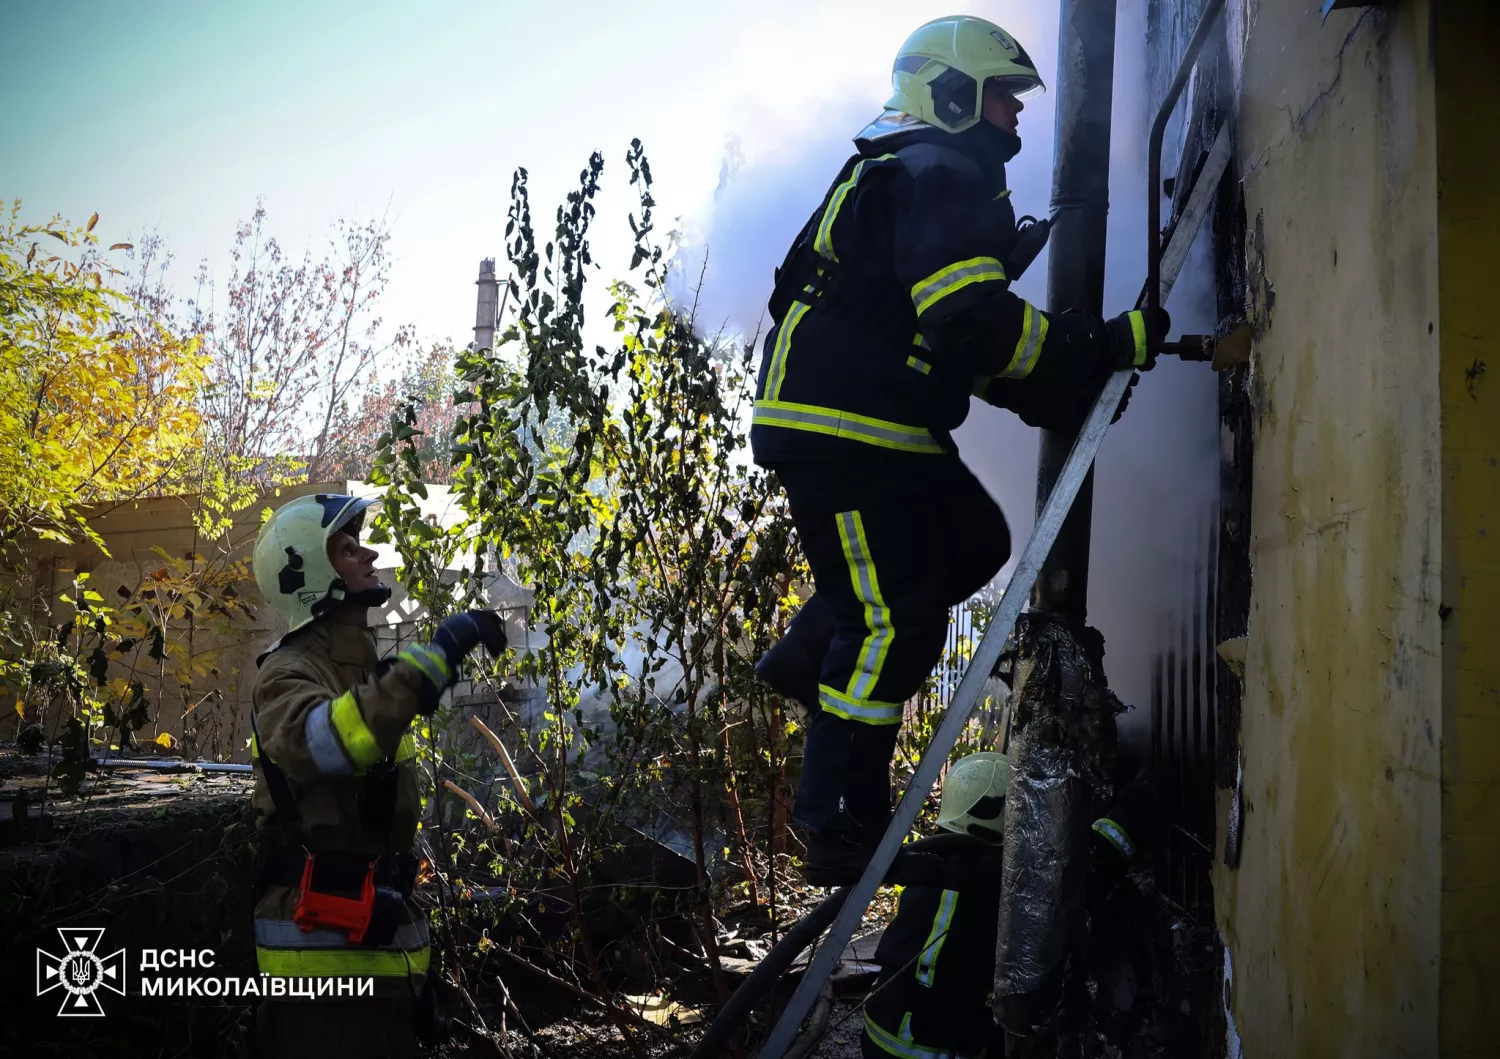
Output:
[1434, 2, 1500, 1056]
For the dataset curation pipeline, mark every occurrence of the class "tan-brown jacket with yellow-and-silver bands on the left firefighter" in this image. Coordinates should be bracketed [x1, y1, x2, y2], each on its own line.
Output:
[252, 620, 432, 995]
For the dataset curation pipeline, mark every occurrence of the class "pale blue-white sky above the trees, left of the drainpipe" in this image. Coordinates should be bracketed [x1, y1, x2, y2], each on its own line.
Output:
[0, 0, 1056, 341]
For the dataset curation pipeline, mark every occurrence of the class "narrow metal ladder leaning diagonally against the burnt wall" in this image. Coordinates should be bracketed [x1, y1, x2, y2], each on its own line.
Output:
[759, 0, 1230, 1059]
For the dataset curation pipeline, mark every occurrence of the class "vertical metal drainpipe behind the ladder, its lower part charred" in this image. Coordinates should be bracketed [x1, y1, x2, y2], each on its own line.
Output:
[995, 0, 1116, 1056]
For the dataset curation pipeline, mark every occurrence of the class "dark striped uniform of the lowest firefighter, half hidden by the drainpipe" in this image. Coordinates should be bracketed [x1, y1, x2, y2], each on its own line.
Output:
[864, 839, 1002, 1059]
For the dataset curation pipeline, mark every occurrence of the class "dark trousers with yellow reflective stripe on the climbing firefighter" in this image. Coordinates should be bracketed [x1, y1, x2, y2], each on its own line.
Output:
[776, 456, 1011, 837]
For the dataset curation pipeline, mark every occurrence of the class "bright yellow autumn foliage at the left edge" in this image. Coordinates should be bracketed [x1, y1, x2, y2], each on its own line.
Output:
[0, 203, 207, 551]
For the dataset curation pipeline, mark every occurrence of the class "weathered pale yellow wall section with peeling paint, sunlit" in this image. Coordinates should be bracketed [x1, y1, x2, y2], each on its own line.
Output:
[1214, 0, 1446, 1059]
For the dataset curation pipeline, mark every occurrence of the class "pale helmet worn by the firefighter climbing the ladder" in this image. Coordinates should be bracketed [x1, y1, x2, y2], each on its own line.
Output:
[885, 15, 1047, 132]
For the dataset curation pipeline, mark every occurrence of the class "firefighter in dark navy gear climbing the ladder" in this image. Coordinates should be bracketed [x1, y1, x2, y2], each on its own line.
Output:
[750, 17, 1170, 887]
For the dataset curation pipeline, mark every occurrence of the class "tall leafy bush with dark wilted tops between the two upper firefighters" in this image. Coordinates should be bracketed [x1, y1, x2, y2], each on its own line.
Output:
[360, 143, 800, 1049]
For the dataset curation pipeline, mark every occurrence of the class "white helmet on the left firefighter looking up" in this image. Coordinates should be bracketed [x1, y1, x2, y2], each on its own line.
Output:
[252, 494, 390, 633]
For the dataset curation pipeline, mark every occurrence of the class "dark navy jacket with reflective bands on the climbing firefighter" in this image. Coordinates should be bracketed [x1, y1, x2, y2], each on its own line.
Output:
[750, 115, 1107, 467]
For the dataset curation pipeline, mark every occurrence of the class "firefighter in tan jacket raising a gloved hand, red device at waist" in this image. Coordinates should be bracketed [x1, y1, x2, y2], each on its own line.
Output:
[251, 494, 506, 1059]
